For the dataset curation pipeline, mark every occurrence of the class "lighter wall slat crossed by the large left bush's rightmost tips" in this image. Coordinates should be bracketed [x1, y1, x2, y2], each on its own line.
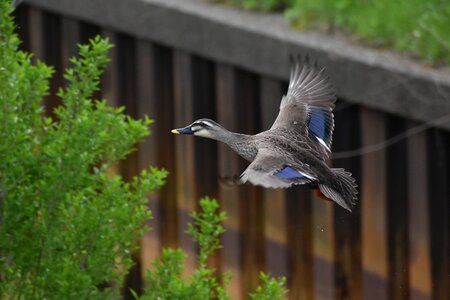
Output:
[136, 40, 161, 274]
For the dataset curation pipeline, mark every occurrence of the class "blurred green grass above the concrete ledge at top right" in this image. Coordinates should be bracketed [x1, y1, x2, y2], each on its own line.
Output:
[210, 0, 450, 64]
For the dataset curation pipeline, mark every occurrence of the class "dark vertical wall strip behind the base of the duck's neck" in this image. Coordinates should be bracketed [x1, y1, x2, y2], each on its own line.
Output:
[234, 70, 265, 293]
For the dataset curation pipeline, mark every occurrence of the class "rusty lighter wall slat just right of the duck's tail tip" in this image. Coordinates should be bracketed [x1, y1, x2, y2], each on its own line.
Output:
[357, 109, 388, 300]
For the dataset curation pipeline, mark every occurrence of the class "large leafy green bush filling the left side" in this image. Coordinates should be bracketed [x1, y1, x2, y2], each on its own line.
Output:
[0, 1, 166, 299]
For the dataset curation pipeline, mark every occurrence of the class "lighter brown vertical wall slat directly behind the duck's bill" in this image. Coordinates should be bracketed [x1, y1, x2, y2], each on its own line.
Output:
[173, 50, 196, 274]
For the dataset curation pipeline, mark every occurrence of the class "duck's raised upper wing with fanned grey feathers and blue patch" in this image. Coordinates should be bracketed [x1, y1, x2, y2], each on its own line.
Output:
[272, 57, 336, 157]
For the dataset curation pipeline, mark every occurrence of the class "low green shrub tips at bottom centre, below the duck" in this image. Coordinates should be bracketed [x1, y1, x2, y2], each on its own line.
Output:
[135, 198, 286, 300]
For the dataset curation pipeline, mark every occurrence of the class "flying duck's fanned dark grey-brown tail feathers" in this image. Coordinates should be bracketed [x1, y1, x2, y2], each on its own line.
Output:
[319, 168, 358, 211]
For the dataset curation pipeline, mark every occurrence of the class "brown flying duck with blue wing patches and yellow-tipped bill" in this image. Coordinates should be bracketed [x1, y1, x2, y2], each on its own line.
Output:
[172, 58, 358, 211]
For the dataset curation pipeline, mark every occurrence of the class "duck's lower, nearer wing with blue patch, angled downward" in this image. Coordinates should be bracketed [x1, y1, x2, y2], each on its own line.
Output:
[241, 149, 317, 188]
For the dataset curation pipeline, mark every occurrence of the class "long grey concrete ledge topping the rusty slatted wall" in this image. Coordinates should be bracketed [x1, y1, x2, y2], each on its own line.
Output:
[26, 0, 450, 129]
